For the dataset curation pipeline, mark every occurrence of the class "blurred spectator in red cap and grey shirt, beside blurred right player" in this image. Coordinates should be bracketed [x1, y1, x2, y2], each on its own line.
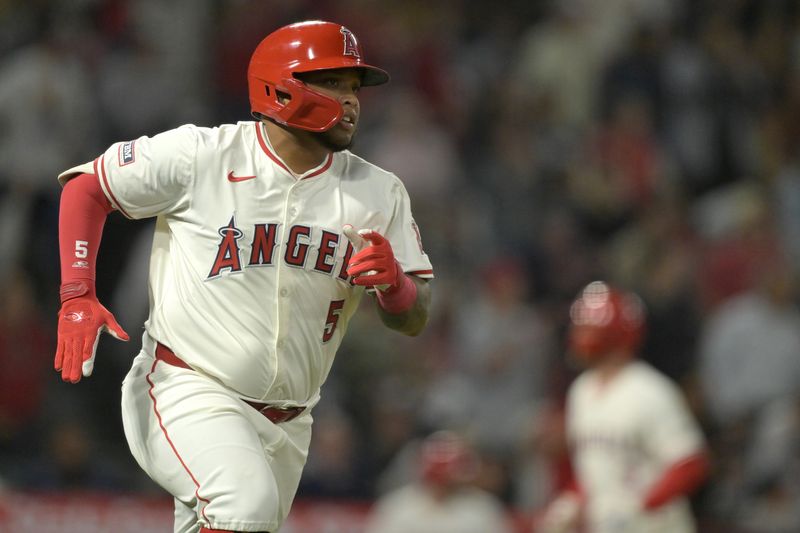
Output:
[438, 256, 554, 459]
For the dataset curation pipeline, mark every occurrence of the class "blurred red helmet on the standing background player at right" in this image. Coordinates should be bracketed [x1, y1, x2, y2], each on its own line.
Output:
[568, 281, 645, 361]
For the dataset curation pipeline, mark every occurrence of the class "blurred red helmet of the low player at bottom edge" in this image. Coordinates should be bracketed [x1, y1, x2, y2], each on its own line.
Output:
[420, 431, 478, 486]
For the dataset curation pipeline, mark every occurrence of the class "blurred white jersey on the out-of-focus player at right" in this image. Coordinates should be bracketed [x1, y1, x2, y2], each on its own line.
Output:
[567, 361, 704, 533]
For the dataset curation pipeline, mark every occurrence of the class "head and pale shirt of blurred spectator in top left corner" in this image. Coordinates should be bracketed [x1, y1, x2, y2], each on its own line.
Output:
[0, 10, 97, 192]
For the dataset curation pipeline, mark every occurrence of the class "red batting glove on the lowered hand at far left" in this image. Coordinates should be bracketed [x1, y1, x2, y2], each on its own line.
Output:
[54, 282, 130, 383]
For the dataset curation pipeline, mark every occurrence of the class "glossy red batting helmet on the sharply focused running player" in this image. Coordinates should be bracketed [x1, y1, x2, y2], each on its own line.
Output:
[247, 20, 389, 132]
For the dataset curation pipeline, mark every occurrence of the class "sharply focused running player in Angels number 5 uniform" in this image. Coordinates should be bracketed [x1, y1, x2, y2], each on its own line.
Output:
[55, 21, 433, 533]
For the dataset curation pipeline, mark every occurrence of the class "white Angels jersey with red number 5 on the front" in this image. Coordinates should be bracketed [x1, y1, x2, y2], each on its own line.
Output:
[59, 122, 433, 406]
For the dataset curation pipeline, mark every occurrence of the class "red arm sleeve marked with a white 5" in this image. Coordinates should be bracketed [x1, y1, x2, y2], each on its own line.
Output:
[58, 174, 113, 302]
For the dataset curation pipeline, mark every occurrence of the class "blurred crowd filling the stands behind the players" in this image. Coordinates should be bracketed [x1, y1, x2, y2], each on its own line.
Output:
[0, 0, 800, 533]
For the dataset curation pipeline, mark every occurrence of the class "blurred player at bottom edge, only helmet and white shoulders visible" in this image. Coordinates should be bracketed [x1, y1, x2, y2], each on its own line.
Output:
[366, 431, 512, 533]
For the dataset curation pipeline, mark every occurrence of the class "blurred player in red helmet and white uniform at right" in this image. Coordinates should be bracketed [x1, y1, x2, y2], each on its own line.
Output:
[536, 281, 708, 533]
